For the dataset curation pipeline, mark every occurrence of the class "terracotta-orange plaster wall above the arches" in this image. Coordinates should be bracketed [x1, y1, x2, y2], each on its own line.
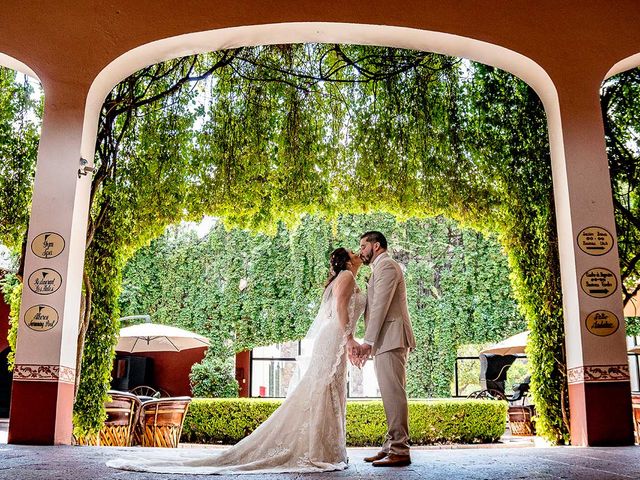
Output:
[0, 0, 640, 88]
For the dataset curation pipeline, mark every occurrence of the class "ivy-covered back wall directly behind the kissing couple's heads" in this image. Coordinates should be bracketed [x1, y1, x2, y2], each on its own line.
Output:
[120, 214, 526, 397]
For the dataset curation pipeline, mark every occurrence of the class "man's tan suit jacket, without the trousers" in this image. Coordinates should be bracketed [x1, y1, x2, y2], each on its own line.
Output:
[364, 253, 416, 355]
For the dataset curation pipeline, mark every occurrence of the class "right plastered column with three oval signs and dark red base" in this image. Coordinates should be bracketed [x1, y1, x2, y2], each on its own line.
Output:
[550, 75, 633, 446]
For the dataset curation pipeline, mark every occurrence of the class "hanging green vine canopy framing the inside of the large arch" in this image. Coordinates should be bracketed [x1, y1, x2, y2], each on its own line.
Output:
[76, 45, 568, 441]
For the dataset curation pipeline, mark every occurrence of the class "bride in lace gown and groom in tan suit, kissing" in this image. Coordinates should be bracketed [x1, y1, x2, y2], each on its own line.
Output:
[107, 231, 415, 475]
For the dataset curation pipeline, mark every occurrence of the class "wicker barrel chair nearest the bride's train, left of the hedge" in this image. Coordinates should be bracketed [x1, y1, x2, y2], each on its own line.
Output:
[137, 397, 191, 448]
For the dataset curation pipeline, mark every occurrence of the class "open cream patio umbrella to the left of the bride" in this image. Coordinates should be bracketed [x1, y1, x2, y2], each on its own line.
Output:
[116, 323, 209, 353]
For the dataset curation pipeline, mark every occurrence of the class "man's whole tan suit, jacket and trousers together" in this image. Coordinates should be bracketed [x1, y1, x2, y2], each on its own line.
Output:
[364, 252, 416, 455]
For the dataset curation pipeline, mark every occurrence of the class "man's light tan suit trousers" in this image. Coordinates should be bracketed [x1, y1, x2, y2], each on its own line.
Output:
[373, 348, 409, 455]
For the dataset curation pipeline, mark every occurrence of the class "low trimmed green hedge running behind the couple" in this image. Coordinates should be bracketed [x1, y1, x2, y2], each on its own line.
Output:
[181, 398, 507, 447]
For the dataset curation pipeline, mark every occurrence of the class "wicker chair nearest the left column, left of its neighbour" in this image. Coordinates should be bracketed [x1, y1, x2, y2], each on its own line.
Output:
[98, 390, 140, 447]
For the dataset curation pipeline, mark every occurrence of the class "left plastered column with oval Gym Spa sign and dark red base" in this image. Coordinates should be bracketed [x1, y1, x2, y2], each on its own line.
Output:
[9, 84, 91, 445]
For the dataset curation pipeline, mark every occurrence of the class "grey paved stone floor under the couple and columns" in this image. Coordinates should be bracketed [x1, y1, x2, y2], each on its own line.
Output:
[0, 445, 640, 480]
